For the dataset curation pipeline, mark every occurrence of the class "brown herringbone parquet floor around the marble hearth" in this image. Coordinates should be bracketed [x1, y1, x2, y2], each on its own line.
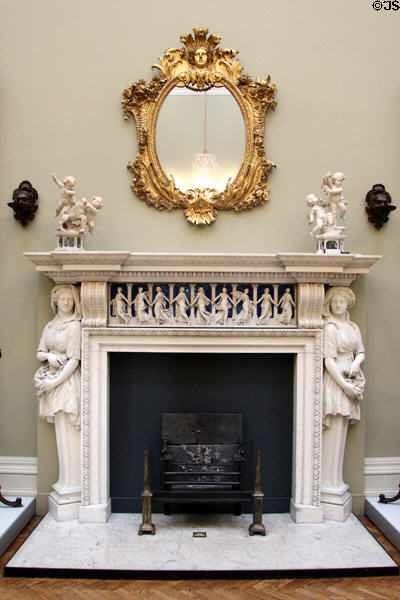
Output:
[0, 517, 400, 600]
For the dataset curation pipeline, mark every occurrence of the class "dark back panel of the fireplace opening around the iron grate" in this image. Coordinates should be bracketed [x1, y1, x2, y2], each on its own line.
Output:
[109, 352, 294, 513]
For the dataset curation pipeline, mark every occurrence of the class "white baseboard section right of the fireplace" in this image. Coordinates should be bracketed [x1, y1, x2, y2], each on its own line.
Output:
[364, 456, 400, 497]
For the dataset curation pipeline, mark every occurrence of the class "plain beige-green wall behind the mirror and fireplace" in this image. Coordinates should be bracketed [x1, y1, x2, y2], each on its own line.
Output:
[0, 0, 400, 510]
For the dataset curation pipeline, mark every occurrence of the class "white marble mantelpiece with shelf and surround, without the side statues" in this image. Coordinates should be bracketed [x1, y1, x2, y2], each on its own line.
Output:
[28, 251, 379, 522]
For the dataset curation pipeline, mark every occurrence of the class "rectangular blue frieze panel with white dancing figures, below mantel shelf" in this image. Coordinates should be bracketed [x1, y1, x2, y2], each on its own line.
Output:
[108, 282, 297, 328]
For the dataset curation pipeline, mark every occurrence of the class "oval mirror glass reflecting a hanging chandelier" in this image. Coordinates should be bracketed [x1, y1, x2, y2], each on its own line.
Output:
[156, 87, 246, 191]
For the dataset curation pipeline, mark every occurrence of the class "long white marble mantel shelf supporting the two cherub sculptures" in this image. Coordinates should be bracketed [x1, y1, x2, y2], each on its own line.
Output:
[25, 250, 381, 285]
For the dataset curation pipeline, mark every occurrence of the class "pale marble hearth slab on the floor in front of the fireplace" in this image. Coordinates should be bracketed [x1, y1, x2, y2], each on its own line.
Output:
[5, 514, 398, 576]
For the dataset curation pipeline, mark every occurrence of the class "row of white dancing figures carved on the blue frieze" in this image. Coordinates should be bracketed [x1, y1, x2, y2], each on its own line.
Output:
[110, 286, 296, 326]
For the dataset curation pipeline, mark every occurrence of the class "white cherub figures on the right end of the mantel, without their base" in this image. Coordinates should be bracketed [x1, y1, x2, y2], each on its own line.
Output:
[306, 171, 347, 238]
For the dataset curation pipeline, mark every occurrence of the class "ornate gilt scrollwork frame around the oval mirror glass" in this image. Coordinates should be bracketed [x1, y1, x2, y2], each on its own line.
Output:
[122, 27, 276, 225]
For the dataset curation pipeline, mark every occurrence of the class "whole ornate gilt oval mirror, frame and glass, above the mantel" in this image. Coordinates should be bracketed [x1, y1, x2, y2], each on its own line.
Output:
[122, 28, 276, 225]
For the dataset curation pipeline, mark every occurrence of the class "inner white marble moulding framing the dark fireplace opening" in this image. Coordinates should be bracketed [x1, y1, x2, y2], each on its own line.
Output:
[79, 328, 322, 522]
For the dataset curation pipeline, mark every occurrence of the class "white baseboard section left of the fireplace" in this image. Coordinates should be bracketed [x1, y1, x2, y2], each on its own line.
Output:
[0, 456, 37, 496]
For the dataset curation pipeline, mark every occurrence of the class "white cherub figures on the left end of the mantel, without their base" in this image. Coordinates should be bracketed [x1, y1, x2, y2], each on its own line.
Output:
[52, 173, 103, 236]
